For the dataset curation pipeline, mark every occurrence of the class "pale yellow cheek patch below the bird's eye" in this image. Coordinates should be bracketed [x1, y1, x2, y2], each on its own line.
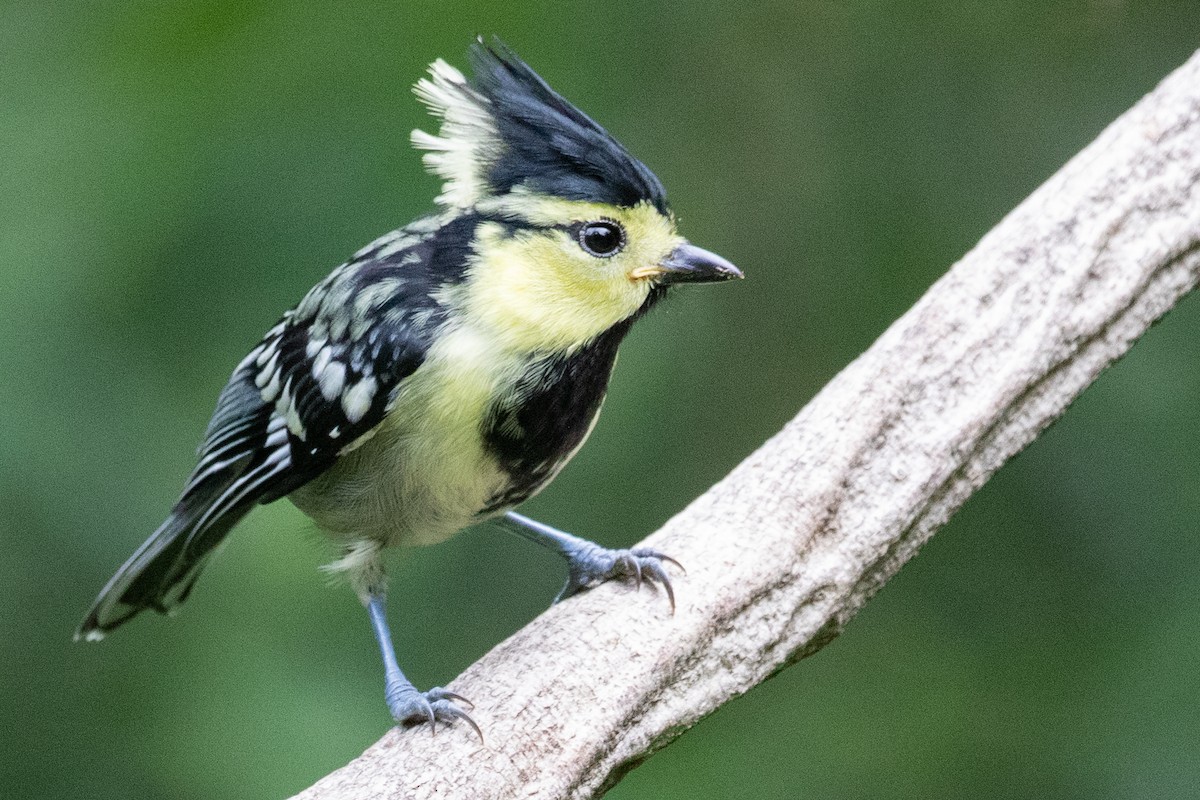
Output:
[466, 229, 649, 350]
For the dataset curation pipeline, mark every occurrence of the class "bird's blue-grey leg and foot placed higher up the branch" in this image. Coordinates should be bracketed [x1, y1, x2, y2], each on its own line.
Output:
[503, 511, 683, 612]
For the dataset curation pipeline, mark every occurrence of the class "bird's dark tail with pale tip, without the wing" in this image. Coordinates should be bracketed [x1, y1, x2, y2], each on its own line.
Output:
[74, 498, 254, 642]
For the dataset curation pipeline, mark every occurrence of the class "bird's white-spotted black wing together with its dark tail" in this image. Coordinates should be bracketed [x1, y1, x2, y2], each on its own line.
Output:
[78, 234, 443, 638]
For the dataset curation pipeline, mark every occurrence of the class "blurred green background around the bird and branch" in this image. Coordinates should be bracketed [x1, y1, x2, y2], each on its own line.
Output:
[0, 0, 1200, 800]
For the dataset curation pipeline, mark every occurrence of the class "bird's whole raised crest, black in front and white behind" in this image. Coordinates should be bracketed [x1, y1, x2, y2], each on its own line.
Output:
[413, 40, 666, 212]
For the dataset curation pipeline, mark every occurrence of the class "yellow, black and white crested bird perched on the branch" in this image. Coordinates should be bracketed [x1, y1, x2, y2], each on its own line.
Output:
[76, 37, 743, 735]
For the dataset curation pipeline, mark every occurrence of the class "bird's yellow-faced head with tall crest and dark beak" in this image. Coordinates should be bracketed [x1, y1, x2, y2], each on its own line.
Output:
[413, 41, 742, 350]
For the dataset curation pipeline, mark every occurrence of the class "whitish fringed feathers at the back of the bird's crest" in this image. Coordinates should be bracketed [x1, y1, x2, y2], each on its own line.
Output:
[412, 59, 500, 209]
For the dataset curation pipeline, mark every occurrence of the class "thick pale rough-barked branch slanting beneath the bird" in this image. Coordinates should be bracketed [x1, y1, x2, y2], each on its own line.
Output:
[290, 53, 1200, 800]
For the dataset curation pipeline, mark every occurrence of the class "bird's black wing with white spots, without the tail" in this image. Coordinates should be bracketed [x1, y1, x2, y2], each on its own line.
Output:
[181, 221, 445, 525]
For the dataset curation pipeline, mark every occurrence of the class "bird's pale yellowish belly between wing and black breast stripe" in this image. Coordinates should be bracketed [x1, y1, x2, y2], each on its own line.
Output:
[289, 331, 524, 546]
